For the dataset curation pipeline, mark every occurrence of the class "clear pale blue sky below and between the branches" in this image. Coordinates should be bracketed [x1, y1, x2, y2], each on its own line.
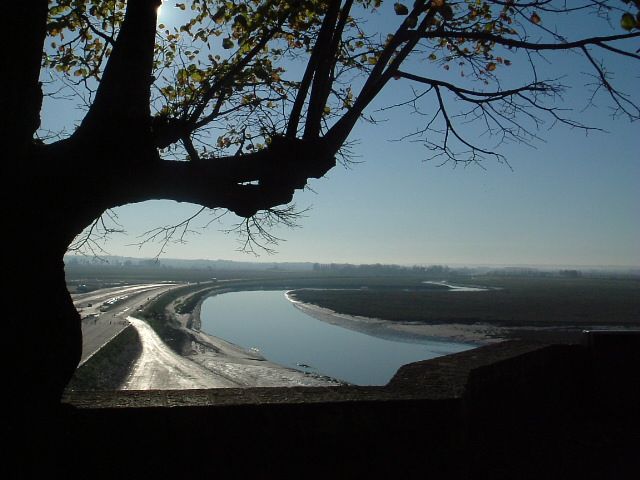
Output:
[43, 2, 640, 267]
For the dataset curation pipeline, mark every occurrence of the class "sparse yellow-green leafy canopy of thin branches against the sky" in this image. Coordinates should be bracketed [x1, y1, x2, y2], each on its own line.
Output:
[43, 0, 640, 161]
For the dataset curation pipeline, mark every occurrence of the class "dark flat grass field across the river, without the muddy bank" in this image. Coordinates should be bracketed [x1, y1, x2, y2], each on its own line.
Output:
[295, 277, 640, 327]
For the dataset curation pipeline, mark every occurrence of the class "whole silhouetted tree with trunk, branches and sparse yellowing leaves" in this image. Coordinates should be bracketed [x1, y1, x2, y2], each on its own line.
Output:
[0, 0, 640, 407]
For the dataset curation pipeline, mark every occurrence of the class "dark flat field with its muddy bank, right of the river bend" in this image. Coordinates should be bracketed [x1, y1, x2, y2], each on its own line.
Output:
[292, 278, 640, 343]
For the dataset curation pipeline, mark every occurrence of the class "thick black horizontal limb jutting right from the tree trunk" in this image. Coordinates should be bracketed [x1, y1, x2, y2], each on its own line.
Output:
[113, 137, 335, 217]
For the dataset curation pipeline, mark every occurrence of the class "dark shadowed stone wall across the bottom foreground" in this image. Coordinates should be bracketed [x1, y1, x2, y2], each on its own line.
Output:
[11, 337, 640, 479]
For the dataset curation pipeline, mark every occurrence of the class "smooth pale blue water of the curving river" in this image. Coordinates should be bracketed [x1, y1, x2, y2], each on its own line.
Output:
[201, 291, 473, 385]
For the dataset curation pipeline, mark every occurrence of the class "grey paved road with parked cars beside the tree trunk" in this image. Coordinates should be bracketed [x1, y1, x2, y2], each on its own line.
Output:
[71, 283, 181, 365]
